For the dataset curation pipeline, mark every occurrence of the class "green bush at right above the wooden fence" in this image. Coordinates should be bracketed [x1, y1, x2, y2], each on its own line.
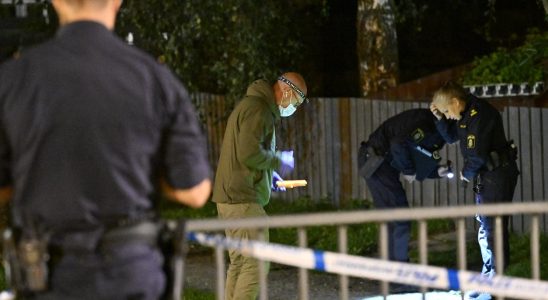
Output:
[463, 30, 548, 85]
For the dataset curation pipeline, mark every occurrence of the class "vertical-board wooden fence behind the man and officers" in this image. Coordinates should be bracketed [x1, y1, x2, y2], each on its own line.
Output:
[195, 95, 548, 232]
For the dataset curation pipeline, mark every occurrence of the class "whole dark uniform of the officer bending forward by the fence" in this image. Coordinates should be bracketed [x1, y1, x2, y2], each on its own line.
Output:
[358, 109, 445, 262]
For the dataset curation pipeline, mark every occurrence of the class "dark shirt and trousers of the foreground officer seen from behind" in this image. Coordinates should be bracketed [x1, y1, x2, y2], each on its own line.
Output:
[0, 21, 210, 299]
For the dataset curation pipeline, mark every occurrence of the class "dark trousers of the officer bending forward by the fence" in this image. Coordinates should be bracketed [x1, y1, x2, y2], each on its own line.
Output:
[365, 160, 411, 262]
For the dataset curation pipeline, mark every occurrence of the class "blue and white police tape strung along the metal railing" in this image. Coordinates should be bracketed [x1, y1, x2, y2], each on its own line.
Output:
[188, 232, 548, 299]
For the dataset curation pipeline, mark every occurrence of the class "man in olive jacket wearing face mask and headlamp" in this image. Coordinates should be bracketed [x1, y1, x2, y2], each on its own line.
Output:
[213, 72, 307, 300]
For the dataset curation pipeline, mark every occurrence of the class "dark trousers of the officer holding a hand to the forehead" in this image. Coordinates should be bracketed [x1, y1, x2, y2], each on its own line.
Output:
[475, 162, 519, 277]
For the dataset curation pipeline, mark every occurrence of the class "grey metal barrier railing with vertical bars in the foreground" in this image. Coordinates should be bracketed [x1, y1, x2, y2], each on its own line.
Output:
[187, 202, 548, 300]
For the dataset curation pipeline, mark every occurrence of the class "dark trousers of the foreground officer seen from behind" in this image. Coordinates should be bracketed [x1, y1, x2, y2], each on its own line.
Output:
[33, 244, 166, 300]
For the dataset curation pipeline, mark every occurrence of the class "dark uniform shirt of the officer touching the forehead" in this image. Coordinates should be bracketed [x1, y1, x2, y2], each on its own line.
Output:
[436, 95, 508, 180]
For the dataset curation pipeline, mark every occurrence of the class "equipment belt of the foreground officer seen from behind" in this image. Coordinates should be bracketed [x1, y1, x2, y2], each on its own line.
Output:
[2, 220, 186, 299]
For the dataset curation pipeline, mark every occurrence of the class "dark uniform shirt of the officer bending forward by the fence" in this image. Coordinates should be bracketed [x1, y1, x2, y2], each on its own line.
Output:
[368, 108, 445, 176]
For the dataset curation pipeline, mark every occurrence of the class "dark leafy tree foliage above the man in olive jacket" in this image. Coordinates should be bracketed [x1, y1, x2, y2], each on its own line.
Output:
[117, 0, 325, 106]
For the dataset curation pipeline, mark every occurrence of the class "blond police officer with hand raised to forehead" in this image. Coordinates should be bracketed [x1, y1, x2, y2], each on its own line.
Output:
[430, 82, 519, 299]
